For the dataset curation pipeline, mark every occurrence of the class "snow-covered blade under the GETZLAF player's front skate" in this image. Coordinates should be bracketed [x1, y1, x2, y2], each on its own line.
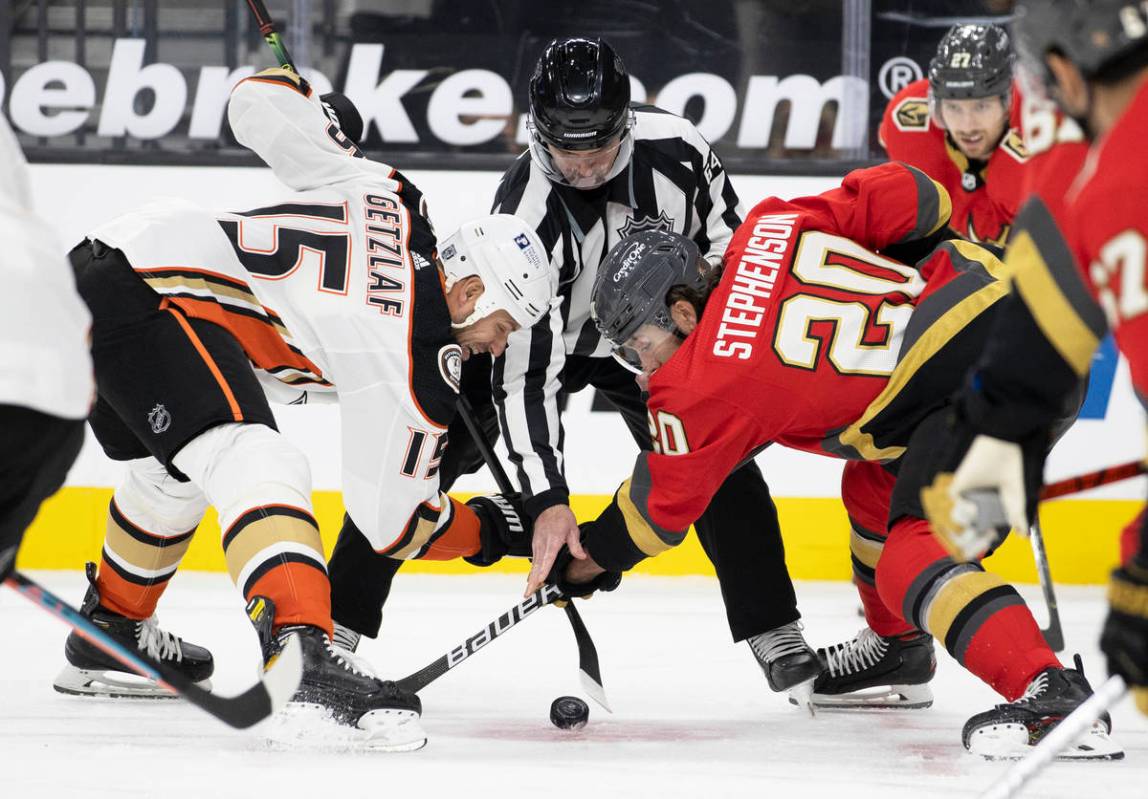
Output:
[263, 703, 427, 752]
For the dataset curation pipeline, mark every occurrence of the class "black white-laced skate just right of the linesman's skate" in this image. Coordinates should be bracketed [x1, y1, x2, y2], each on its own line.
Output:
[794, 627, 937, 709]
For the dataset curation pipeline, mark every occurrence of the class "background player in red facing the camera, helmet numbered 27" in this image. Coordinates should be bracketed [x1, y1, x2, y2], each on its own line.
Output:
[878, 24, 1029, 247]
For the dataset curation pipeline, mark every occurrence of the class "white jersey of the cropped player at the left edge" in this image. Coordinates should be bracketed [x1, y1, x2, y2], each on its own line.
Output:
[0, 115, 95, 419]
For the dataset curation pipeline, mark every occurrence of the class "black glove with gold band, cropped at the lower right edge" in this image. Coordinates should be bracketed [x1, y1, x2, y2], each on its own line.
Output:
[1100, 560, 1148, 714]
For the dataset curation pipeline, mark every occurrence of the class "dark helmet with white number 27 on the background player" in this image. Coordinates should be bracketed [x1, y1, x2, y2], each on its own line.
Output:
[929, 24, 1013, 100]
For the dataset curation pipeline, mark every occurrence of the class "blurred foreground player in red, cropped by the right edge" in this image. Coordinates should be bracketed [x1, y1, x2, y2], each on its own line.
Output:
[926, 0, 1148, 727]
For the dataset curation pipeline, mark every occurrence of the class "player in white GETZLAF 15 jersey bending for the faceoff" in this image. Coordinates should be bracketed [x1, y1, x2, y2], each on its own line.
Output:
[56, 69, 556, 750]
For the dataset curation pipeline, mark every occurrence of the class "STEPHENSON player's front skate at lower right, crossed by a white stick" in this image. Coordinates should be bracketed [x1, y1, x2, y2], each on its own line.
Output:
[961, 654, 1124, 760]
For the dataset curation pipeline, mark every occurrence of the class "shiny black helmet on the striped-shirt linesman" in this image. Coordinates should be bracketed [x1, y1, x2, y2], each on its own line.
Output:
[530, 37, 630, 150]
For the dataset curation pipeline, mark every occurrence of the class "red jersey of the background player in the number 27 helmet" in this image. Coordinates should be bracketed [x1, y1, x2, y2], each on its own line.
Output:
[878, 78, 1029, 247]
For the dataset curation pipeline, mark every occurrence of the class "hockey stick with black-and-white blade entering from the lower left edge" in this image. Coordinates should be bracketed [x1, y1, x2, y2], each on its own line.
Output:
[5, 572, 303, 729]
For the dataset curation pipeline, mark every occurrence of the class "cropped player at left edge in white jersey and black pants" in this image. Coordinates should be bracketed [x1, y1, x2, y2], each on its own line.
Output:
[0, 115, 94, 582]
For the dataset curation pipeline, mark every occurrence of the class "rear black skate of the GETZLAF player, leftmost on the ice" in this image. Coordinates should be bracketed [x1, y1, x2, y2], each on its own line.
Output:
[52, 563, 215, 699]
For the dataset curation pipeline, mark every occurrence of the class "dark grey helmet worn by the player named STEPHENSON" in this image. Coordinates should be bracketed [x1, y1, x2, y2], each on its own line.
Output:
[590, 231, 709, 367]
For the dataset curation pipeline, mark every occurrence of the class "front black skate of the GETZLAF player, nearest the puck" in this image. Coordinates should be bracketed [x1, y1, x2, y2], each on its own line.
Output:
[247, 597, 427, 752]
